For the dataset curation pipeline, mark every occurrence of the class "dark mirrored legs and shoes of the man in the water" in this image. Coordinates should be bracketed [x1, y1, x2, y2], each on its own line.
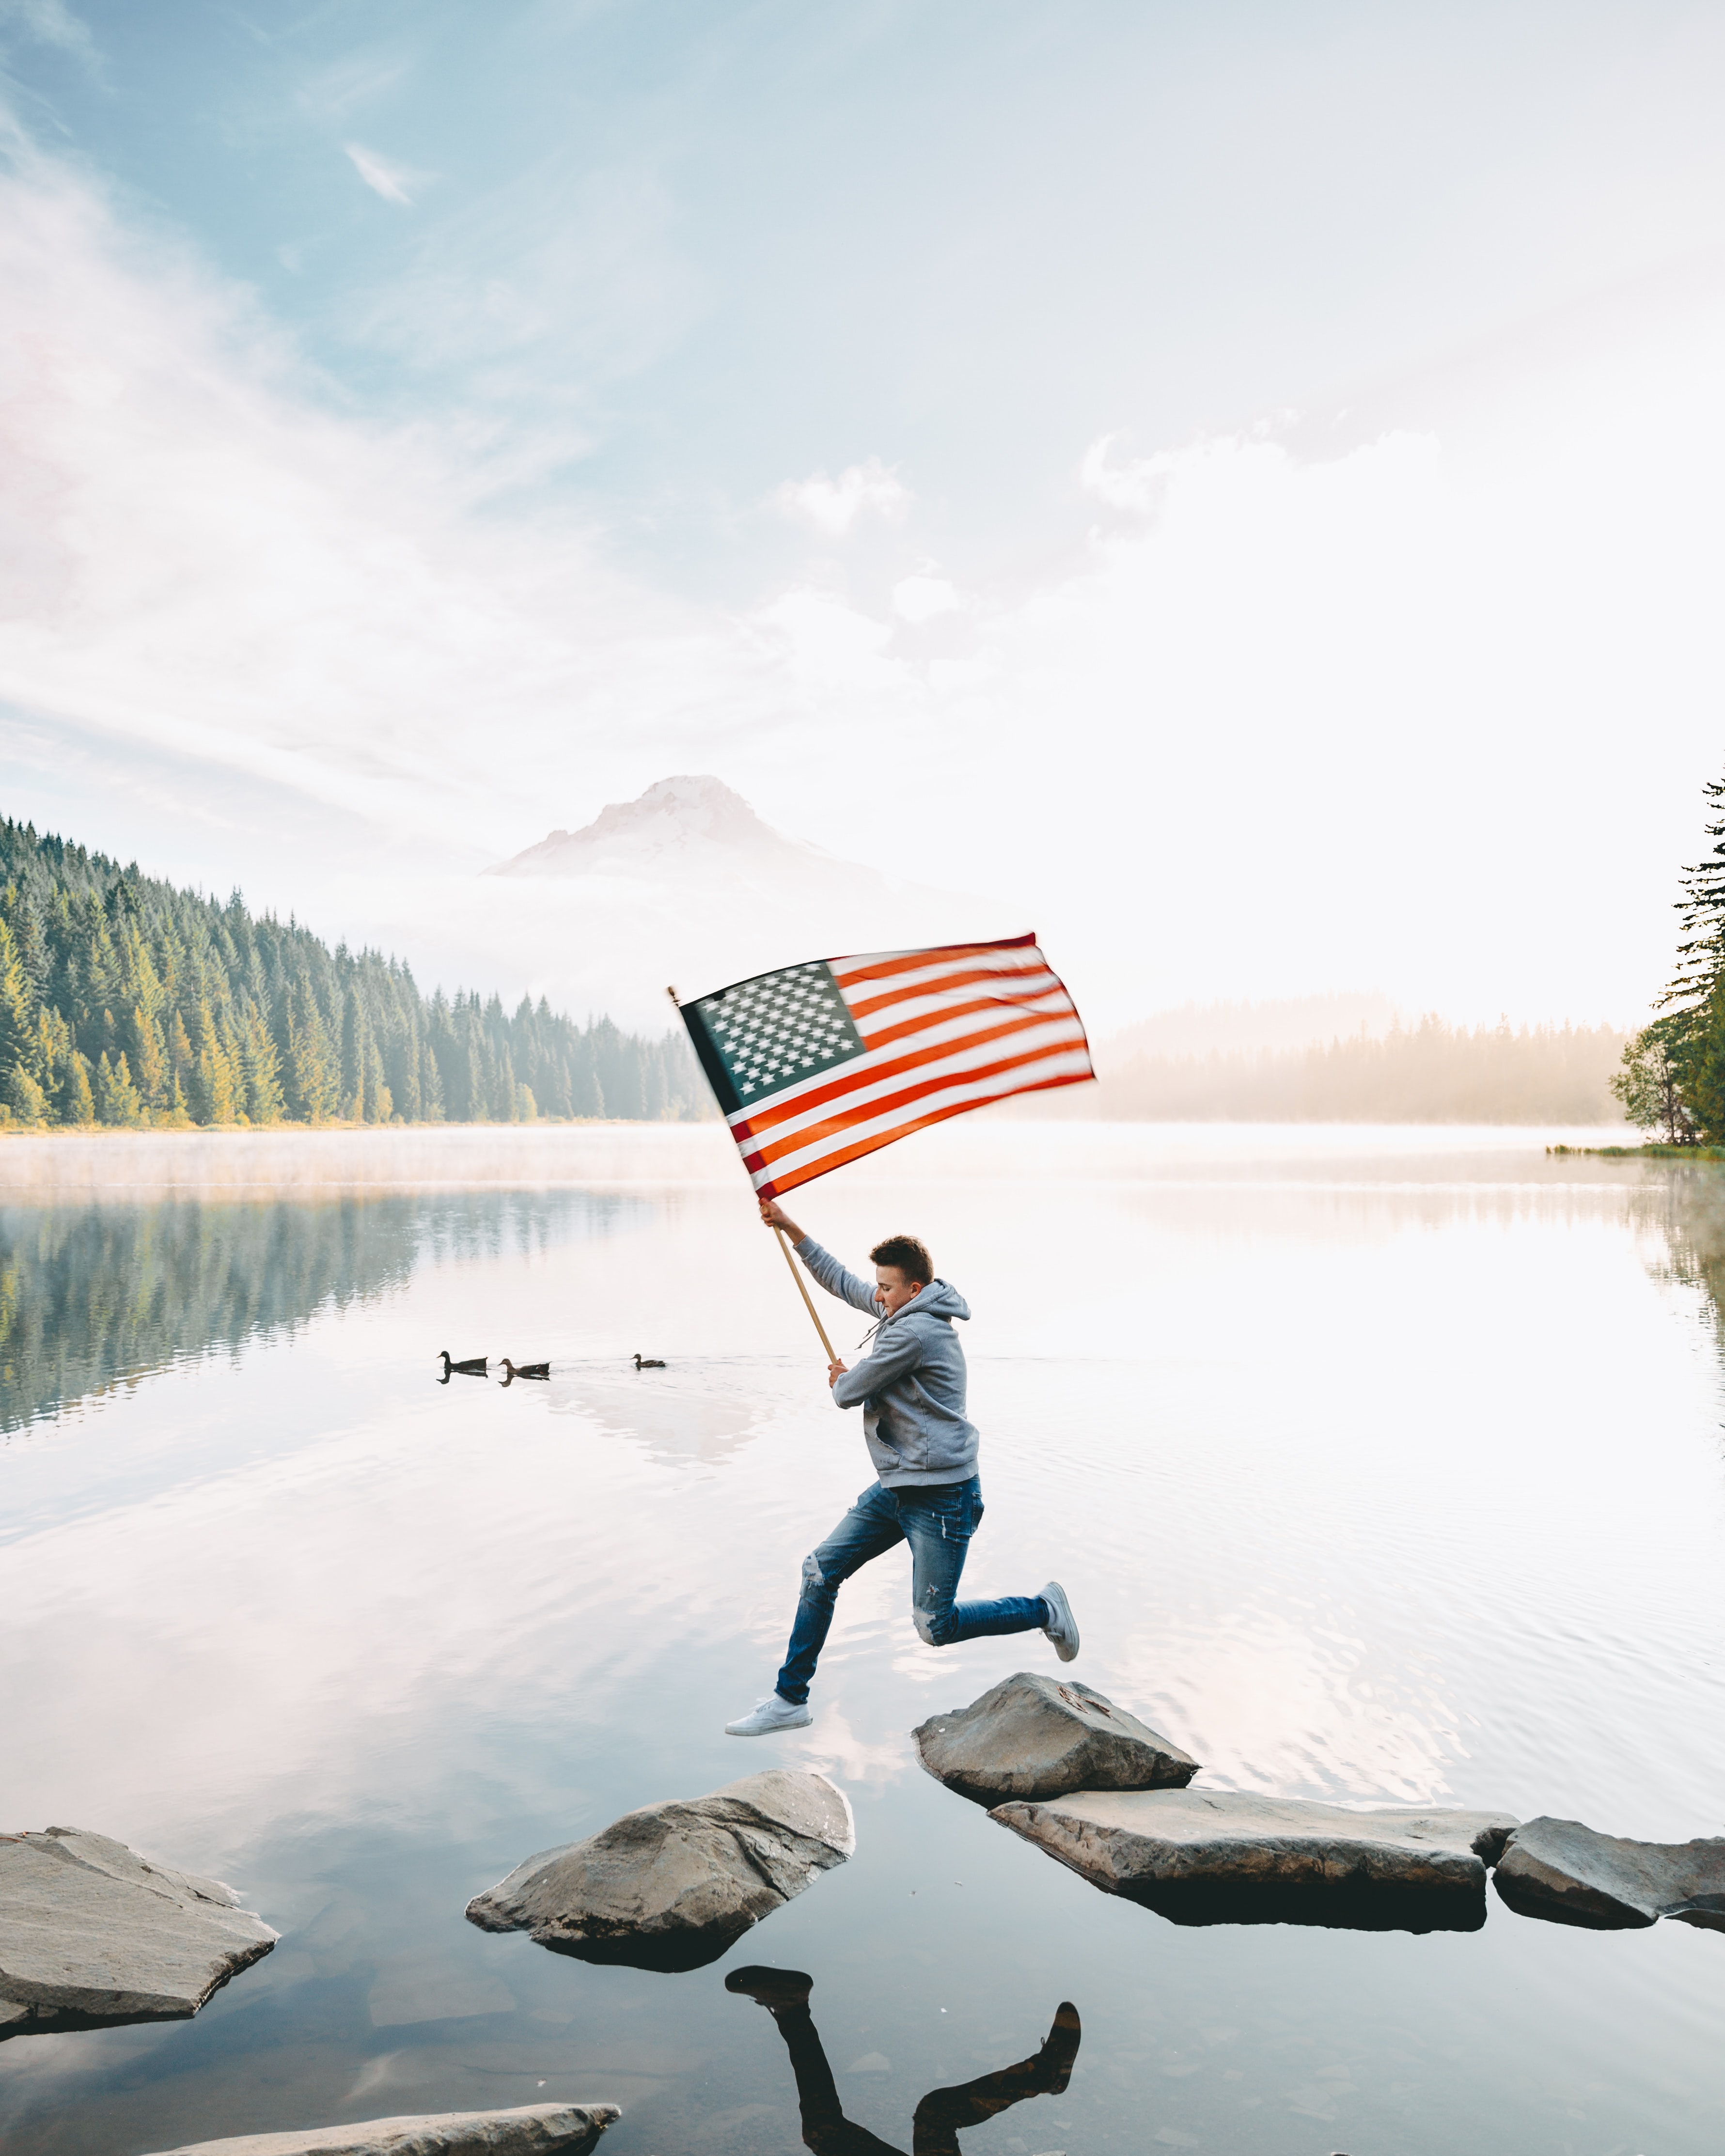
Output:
[724, 1969, 1080, 2156]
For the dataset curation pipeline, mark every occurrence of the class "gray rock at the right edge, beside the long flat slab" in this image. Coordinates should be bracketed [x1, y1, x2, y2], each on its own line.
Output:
[1496, 1820, 1725, 1932]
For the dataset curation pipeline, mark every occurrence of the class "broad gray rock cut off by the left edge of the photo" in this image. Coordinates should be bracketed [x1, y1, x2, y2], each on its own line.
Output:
[0, 1826, 278, 2037]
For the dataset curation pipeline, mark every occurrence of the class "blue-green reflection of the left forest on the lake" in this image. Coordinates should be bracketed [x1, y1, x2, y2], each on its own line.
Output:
[0, 1190, 641, 1429]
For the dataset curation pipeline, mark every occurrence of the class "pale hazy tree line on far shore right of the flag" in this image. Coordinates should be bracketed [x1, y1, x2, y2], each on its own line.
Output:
[1031, 1017, 1624, 1123]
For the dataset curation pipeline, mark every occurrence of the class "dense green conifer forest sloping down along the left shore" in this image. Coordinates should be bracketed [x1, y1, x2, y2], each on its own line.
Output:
[0, 819, 712, 1127]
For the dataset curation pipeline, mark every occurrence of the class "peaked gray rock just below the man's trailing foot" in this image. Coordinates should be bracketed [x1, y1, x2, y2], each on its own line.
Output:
[916, 1669, 1199, 1805]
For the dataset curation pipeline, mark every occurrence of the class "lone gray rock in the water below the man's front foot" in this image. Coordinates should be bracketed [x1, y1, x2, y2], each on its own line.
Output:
[468, 1768, 856, 1969]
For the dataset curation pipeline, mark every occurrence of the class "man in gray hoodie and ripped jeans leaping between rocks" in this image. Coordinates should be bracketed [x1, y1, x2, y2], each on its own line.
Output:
[724, 1199, 1078, 1738]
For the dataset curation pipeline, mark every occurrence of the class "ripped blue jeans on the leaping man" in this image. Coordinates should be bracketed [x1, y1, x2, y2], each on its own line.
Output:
[776, 1475, 1048, 1705]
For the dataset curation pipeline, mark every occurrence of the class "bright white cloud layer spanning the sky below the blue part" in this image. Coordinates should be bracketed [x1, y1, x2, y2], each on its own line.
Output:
[0, 143, 1725, 1031]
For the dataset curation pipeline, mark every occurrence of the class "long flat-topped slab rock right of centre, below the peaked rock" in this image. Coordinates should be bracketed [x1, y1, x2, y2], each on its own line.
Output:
[990, 1790, 1516, 1930]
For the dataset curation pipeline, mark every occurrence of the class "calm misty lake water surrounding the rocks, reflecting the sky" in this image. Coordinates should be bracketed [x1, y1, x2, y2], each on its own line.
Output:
[0, 1119, 1725, 2156]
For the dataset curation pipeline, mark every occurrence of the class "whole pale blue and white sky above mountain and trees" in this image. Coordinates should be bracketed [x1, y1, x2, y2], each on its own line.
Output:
[0, 0, 1725, 1029]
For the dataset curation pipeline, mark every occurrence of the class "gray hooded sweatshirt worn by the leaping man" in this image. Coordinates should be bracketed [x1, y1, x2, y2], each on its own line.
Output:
[796, 1235, 979, 1490]
